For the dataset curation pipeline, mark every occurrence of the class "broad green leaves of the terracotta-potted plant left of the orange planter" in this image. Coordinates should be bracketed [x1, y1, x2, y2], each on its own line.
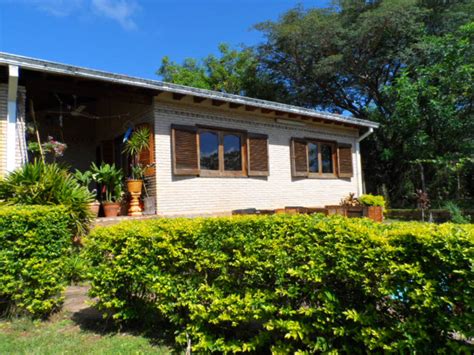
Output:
[91, 162, 123, 202]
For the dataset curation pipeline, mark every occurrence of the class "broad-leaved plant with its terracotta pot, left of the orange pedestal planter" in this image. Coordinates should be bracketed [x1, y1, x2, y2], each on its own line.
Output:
[91, 163, 123, 217]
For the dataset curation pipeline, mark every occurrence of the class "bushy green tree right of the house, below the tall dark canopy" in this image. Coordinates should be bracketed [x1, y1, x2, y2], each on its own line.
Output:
[366, 22, 474, 206]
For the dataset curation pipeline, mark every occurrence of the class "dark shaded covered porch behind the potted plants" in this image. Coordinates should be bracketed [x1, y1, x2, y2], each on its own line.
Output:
[17, 69, 156, 216]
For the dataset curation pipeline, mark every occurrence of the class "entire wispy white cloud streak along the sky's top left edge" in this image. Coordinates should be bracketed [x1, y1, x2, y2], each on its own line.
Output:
[22, 0, 140, 30]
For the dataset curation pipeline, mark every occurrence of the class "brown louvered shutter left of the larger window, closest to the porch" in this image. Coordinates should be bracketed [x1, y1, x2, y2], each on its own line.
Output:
[171, 125, 199, 175]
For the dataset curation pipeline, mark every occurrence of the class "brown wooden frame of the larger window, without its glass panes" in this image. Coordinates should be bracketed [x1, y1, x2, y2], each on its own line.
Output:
[197, 126, 247, 177]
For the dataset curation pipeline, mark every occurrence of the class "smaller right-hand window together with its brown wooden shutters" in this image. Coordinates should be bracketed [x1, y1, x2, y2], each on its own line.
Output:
[291, 138, 346, 178]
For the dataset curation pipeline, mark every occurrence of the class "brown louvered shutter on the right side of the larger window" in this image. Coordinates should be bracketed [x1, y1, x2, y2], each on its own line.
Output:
[247, 133, 269, 176]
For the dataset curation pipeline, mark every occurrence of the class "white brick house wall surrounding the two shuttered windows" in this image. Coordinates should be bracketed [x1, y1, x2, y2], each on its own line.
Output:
[155, 102, 359, 215]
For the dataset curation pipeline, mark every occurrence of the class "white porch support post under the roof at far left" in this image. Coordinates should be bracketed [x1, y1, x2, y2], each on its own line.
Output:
[6, 65, 19, 172]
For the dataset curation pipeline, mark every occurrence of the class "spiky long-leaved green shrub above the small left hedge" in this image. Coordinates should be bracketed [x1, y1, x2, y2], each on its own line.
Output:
[0, 160, 94, 235]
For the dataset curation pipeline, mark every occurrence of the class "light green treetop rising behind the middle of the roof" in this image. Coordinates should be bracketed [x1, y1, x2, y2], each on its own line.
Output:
[157, 43, 284, 100]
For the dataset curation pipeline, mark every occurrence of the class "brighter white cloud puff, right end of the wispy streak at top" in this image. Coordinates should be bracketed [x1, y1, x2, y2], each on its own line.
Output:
[92, 0, 138, 30]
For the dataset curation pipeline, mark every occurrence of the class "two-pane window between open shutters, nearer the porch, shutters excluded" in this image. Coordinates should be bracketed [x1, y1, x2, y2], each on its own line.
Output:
[198, 129, 244, 176]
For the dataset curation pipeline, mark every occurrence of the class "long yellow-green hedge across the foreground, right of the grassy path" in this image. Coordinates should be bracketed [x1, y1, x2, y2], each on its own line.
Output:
[85, 215, 474, 353]
